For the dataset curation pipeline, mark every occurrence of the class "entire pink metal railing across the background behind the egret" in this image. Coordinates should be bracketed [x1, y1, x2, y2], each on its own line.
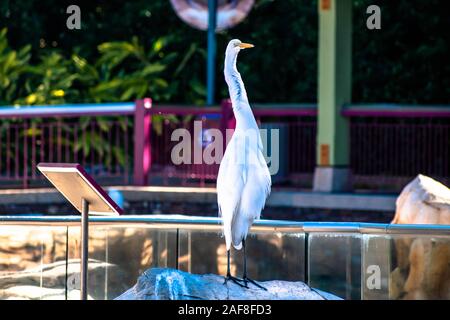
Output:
[0, 99, 450, 191]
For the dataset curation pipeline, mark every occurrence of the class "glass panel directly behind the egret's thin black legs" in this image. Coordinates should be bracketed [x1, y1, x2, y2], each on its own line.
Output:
[179, 230, 305, 281]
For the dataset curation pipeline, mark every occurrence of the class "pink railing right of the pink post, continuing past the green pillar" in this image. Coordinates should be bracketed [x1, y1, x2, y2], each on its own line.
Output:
[138, 101, 450, 191]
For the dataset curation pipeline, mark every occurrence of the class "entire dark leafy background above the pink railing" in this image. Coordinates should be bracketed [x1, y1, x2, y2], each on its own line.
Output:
[0, 0, 450, 104]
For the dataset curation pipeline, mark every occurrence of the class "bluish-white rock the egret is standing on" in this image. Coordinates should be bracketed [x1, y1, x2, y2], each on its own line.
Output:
[116, 268, 341, 300]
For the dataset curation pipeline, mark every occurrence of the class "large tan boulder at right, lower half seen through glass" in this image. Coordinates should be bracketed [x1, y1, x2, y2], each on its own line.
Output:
[390, 175, 450, 299]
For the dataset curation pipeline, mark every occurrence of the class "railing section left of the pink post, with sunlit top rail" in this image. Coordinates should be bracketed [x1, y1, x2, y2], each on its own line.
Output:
[0, 103, 135, 188]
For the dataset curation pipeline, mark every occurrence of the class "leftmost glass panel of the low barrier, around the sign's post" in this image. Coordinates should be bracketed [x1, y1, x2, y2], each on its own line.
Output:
[0, 225, 67, 300]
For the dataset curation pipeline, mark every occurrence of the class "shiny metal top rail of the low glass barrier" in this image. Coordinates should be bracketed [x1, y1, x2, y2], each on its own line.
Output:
[0, 215, 450, 236]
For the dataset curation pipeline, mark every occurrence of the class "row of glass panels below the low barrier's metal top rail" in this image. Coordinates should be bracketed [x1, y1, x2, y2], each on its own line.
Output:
[0, 220, 450, 300]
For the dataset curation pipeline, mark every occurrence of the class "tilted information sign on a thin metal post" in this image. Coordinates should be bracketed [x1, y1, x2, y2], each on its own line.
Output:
[37, 163, 123, 300]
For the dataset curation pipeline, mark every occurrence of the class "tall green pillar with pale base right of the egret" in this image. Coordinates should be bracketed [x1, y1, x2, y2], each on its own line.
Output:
[314, 0, 352, 192]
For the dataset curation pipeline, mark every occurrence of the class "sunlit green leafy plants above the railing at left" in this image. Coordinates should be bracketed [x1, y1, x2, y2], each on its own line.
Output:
[0, 29, 203, 105]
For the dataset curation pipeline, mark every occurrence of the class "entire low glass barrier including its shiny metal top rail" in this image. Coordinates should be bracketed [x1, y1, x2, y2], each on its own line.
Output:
[0, 215, 450, 299]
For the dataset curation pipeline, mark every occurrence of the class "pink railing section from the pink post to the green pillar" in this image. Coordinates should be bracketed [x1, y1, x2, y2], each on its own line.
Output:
[134, 100, 316, 186]
